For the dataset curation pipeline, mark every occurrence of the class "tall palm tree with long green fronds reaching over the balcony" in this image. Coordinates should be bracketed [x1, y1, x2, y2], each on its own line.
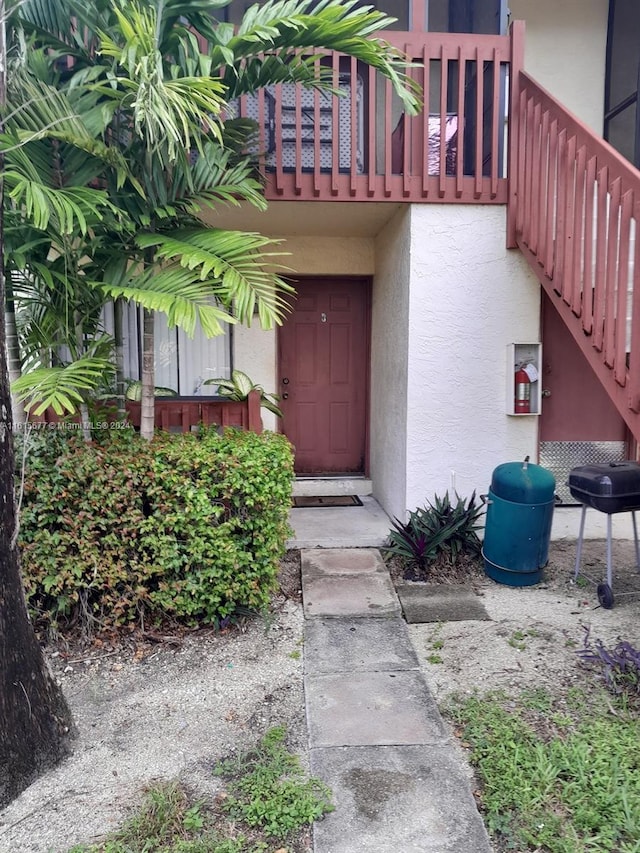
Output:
[10, 0, 418, 437]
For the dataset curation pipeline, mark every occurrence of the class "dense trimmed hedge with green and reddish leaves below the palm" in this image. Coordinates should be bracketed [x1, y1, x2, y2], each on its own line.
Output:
[20, 430, 293, 627]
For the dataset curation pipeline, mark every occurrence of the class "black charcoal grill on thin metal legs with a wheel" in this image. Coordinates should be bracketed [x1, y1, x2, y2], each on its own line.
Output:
[567, 461, 640, 609]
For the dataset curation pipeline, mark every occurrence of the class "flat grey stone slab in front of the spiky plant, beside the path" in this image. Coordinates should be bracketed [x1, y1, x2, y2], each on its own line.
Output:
[396, 583, 491, 624]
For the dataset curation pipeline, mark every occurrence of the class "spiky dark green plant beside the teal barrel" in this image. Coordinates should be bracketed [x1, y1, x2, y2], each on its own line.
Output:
[383, 492, 482, 570]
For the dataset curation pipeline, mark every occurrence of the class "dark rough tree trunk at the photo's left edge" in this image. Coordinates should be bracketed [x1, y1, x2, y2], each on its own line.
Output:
[0, 0, 72, 806]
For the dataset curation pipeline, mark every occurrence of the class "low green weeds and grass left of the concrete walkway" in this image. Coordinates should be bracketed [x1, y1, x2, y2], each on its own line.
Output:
[69, 726, 333, 853]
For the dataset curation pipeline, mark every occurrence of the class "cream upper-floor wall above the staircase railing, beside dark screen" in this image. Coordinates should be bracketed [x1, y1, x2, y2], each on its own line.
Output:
[509, 0, 609, 134]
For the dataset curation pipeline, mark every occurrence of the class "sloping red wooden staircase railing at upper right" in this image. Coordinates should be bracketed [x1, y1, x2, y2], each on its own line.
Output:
[508, 66, 640, 440]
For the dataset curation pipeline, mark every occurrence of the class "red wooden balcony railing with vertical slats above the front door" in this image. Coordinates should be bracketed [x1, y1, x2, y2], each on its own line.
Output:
[232, 27, 523, 204]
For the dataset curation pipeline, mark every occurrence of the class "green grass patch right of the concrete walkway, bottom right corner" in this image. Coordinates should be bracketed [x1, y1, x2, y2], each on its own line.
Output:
[445, 690, 640, 853]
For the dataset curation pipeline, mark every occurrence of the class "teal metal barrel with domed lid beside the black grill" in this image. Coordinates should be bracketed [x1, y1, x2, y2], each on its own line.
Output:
[482, 460, 556, 586]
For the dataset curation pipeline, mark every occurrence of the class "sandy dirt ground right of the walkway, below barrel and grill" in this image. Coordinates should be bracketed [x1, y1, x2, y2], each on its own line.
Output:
[405, 540, 640, 703]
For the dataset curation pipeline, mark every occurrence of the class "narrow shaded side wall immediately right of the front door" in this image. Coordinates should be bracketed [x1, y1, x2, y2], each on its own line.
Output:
[369, 207, 411, 517]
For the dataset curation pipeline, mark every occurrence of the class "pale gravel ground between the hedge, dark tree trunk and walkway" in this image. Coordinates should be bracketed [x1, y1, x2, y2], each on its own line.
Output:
[0, 600, 307, 853]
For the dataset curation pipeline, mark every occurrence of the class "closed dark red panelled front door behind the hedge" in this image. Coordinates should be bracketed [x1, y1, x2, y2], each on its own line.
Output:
[278, 279, 370, 474]
